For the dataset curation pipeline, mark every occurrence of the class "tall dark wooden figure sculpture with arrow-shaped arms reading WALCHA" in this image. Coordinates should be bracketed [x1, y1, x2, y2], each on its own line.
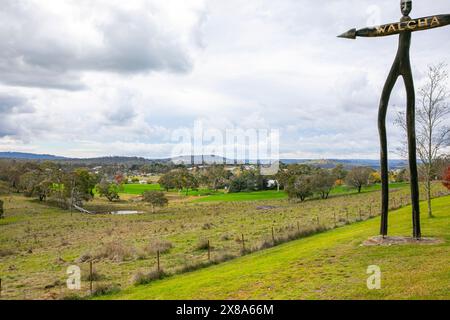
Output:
[339, 0, 450, 239]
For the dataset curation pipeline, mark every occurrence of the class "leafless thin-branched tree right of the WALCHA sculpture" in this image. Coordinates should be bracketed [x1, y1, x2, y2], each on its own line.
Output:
[395, 63, 450, 217]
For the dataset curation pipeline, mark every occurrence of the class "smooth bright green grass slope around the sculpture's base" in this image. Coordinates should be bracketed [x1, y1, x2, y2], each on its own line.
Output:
[102, 197, 450, 299]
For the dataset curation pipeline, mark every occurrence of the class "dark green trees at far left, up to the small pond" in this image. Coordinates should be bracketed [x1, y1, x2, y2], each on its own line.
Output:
[0, 161, 168, 212]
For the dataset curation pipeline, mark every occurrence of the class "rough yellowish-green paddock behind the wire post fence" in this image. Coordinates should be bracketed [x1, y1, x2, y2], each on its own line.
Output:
[0, 185, 443, 299]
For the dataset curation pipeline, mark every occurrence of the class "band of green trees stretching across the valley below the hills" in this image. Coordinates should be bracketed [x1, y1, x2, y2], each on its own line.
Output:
[0, 152, 450, 215]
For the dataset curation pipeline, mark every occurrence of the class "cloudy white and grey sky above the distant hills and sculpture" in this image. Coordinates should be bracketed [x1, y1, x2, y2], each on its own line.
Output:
[0, 0, 450, 158]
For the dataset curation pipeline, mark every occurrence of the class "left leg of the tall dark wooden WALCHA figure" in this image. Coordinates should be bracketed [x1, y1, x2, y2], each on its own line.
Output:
[378, 60, 399, 237]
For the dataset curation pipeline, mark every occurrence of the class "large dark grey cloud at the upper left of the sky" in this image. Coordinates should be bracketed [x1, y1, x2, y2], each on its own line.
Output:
[0, 0, 191, 90]
